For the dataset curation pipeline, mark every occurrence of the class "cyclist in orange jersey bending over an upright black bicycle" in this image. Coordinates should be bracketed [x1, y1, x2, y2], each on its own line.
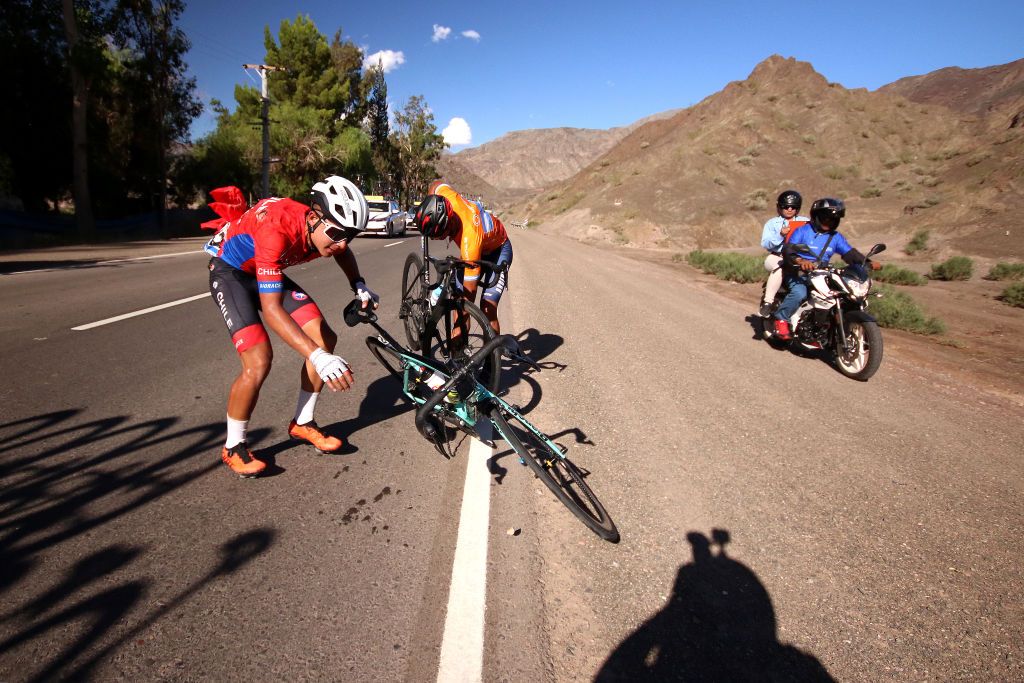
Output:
[413, 180, 512, 334]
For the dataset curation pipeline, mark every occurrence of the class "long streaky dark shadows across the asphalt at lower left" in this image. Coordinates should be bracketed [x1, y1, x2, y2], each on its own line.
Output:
[0, 410, 273, 681]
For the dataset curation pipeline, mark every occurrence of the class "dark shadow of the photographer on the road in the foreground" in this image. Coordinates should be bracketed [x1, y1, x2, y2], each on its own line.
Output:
[594, 529, 834, 683]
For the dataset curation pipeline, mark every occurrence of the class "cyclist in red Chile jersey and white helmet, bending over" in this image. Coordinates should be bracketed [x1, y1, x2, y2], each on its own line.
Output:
[204, 176, 380, 477]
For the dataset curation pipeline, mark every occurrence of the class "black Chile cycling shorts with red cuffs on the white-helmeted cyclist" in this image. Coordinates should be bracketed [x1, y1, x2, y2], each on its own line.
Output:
[210, 256, 324, 353]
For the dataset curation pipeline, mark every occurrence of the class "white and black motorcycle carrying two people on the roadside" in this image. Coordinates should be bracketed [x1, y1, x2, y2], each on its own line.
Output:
[761, 244, 886, 382]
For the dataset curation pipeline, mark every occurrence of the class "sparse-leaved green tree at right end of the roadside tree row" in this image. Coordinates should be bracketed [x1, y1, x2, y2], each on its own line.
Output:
[392, 95, 447, 204]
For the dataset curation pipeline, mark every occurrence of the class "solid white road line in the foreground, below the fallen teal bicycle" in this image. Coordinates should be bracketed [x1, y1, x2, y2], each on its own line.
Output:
[437, 433, 493, 683]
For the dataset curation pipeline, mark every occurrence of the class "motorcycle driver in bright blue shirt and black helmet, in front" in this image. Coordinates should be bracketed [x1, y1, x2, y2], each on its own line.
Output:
[775, 197, 882, 340]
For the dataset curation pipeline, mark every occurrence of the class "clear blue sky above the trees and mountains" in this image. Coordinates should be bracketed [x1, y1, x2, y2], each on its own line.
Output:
[181, 0, 1024, 151]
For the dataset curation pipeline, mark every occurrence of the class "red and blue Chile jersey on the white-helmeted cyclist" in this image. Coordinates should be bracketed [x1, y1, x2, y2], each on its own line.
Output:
[205, 197, 319, 292]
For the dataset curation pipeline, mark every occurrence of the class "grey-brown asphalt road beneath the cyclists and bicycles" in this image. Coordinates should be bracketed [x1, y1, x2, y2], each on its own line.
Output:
[0, 231, 1024, 681]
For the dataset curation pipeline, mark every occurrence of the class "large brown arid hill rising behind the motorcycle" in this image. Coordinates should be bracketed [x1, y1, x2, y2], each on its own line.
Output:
[520, 56, 1024, 257]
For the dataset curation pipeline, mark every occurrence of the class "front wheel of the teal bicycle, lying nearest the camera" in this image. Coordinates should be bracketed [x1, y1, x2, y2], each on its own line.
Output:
[489, 409, 618, 543]
